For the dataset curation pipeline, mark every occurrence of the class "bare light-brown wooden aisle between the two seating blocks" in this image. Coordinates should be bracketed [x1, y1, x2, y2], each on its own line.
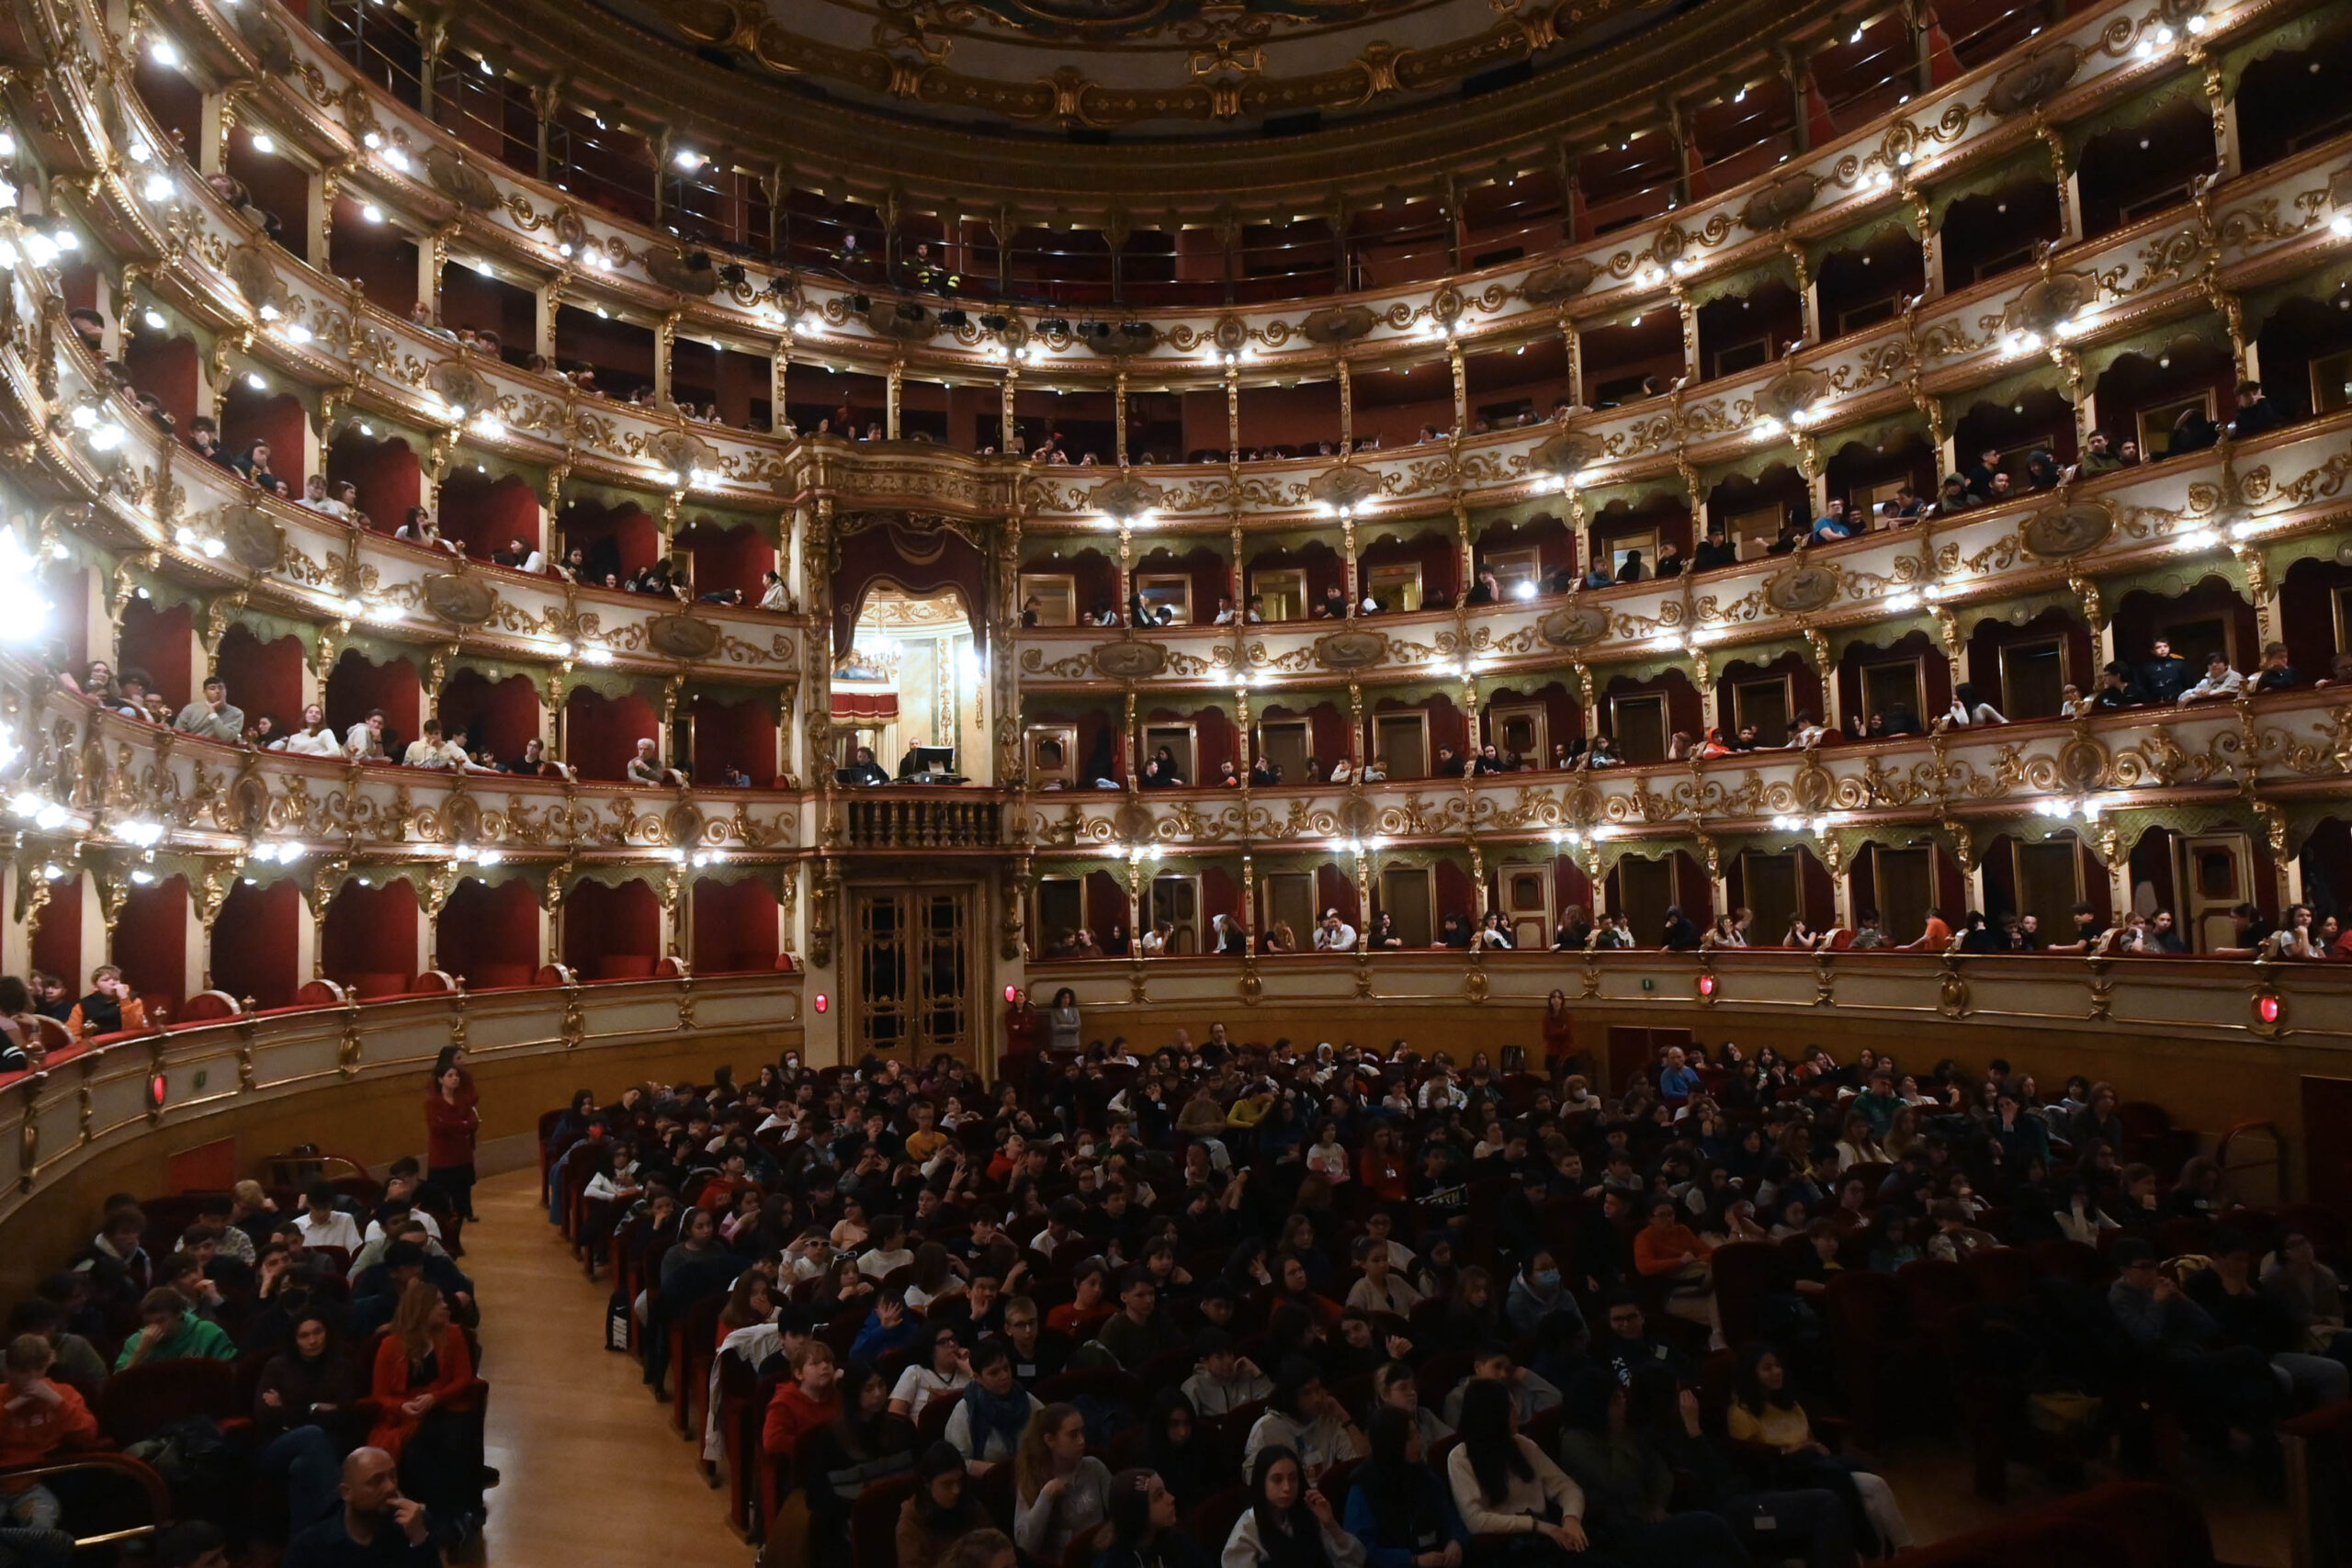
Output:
[461, 1170, 752, 1568]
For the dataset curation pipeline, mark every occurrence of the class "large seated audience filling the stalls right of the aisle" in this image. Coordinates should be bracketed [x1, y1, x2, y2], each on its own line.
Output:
[524, 1024, 2352, 1568]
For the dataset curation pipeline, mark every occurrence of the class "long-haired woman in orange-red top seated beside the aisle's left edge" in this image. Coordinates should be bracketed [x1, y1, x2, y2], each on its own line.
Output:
[367, 1279, 482, 1538]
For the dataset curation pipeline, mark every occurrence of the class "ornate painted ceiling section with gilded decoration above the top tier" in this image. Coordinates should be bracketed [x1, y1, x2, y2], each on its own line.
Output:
[593, 0, 1702, 136]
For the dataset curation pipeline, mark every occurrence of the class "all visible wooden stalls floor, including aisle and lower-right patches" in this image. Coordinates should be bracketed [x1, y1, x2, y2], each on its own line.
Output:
[463, 1170, 2289, 1568]
